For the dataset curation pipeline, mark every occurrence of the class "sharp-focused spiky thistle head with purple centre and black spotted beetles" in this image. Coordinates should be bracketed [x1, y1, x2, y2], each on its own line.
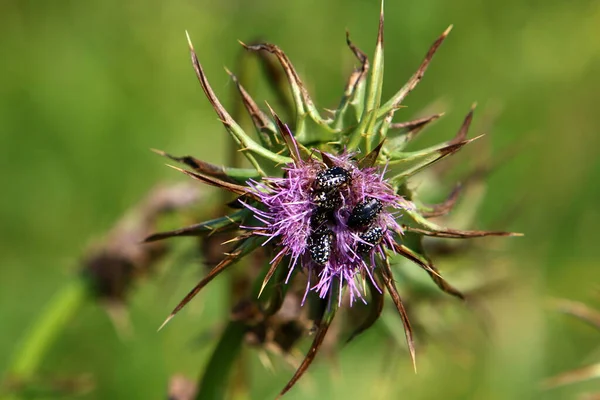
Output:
[146, 2, 513, 394]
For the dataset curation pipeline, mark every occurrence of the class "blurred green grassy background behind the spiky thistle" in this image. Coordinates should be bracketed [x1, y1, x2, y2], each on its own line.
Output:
[0, 0, 600, 399]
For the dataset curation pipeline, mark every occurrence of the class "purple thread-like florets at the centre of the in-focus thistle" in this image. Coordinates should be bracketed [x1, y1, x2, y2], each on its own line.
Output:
[245, 147, 413, 305]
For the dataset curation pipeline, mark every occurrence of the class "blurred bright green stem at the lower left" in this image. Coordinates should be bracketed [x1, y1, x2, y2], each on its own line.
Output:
[7, 278, 88, 383]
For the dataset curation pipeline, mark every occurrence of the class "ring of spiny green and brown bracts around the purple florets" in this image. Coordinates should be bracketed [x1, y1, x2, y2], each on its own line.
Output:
[146, 2, 515, 396]
